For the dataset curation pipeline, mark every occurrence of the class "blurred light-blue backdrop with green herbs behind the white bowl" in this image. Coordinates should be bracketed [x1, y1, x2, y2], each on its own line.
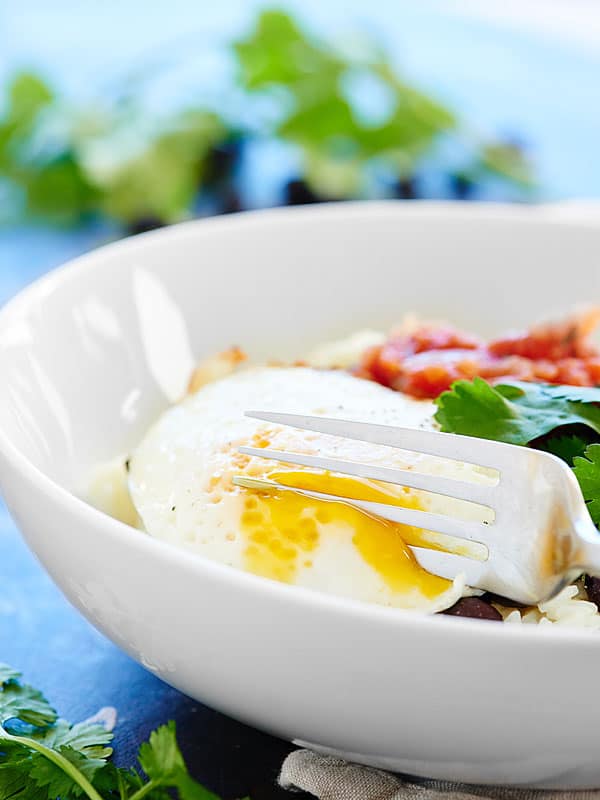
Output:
[0, 0, 600, 302]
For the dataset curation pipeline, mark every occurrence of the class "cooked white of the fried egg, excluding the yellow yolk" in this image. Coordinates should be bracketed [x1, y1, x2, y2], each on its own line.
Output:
[129, 367, 489, 612]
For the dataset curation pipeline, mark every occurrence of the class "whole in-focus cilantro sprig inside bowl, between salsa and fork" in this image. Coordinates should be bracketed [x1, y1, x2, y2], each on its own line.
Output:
[435, 378, 600, 527]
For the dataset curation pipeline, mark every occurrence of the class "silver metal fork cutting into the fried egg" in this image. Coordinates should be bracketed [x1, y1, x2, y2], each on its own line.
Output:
[234, 411, 600, 604]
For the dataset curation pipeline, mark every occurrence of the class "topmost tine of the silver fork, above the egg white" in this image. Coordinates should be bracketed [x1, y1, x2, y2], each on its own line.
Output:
[246, 411, 515, 470]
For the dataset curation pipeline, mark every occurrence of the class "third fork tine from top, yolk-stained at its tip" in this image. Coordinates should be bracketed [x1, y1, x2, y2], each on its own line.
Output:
[233, 475, 488, 545]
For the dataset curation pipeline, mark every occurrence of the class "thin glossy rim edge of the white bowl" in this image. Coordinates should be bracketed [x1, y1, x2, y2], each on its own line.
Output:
[0, 200, 599, 647]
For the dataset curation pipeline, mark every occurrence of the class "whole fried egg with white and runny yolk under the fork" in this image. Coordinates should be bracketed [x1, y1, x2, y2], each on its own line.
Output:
[129, 367, 490, 612]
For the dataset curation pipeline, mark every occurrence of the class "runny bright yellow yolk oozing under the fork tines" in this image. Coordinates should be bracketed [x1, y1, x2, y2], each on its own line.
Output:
[241, 471, 451, 598]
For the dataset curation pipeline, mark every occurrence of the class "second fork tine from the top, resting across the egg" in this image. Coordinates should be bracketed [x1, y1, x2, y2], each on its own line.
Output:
[238, 447, 494, 505]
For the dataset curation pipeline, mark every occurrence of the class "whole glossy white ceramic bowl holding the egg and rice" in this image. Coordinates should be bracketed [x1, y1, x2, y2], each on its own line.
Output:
[0, 203, 600, 787]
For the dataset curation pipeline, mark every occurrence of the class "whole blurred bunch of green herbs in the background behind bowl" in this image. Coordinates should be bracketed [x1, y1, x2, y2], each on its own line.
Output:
[0, 9, 534, 227]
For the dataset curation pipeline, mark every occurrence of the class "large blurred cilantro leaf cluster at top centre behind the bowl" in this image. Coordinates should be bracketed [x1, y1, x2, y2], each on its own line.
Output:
[234, 10, 458, 197]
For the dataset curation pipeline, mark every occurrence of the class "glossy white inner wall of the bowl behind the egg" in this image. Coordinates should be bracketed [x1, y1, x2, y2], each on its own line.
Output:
[0, 203, 600, 490]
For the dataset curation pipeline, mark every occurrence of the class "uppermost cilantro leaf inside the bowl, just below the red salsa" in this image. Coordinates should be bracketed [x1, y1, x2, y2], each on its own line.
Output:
[435, 378, 600, 445]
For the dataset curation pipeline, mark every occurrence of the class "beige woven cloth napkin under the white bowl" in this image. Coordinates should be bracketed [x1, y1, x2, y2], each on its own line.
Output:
[279, 750, 600, 800]
